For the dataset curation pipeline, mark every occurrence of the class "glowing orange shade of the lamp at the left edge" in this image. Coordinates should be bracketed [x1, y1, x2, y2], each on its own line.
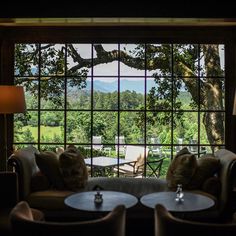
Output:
[0, 85, 26, 114]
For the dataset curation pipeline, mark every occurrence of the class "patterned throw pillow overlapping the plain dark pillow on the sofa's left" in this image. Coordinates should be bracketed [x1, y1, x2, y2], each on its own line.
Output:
[59, 147, 88, 191]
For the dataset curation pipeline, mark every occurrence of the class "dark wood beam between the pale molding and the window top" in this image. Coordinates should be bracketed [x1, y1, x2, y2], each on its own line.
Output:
[0, 26, 236, 43]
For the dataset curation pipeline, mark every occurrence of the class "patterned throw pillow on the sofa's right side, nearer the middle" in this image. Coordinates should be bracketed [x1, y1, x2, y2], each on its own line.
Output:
[166, 148, 197, 190]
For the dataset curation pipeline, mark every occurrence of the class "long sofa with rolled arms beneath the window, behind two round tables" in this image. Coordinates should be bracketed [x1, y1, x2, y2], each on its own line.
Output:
[8, 147, 236, 235]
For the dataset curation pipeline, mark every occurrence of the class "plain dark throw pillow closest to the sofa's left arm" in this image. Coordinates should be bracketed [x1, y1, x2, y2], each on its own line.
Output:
[35, 151, 64, 190]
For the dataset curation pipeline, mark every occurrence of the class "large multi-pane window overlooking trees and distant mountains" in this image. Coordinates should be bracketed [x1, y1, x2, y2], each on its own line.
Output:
[14, 43, 225, 177]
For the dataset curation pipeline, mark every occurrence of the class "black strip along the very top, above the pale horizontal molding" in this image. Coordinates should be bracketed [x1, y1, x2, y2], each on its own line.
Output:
[0, 0, 235, 18]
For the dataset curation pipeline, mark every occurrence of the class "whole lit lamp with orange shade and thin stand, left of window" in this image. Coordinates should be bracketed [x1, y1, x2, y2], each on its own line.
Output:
[0, 85, 26, 170]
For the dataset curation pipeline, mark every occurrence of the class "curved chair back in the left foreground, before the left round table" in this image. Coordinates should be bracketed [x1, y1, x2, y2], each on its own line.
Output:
[10, 201, 126, 236]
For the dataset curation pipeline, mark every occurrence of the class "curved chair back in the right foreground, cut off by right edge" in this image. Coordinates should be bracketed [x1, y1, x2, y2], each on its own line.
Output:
[154, 203, 236, 236]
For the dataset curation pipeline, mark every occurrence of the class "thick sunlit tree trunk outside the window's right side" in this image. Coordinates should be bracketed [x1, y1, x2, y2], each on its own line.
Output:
[201, 45, 225, 152]
